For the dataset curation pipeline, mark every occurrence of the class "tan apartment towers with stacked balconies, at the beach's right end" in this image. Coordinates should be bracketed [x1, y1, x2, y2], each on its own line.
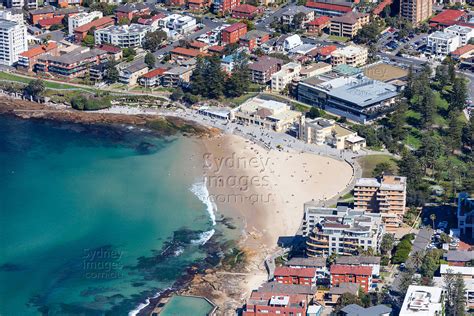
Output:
[354, 175, 407, 227]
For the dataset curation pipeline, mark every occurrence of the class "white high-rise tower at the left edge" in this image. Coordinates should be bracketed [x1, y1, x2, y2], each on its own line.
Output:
[0, 19, 28, 66]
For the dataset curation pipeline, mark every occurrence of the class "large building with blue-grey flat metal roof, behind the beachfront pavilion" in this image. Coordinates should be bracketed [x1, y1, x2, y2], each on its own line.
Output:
[298, 74, 398, 123]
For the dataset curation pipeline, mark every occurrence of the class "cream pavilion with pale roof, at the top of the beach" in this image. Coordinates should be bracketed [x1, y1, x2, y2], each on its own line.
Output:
[234, 98, 302, 132]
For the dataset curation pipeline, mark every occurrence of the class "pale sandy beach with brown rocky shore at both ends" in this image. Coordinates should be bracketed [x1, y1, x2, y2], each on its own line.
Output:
[0, 96, 353, 315]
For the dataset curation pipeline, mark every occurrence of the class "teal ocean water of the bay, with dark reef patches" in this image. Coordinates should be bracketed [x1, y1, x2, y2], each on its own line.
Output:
[0, 116, 221, 316]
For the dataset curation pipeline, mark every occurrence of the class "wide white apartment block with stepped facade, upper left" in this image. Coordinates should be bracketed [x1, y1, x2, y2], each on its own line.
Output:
[94, 24, 151, 47]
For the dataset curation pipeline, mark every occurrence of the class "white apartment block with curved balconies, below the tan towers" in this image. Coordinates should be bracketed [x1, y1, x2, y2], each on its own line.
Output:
[303, 202, 385, 257]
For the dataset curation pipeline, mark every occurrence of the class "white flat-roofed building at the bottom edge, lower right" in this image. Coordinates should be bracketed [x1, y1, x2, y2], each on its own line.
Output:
[400, 285, 443, 316]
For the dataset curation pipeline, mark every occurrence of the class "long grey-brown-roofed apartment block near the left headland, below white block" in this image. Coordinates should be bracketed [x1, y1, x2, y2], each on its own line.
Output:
[36, 47, 107, 79]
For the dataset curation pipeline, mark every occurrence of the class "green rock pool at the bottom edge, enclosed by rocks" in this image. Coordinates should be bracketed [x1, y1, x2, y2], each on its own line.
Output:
[160, 296, 213, 316]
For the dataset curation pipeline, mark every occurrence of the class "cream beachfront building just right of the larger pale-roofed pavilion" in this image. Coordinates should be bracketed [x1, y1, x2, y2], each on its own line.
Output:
[298, 117, 366, 151]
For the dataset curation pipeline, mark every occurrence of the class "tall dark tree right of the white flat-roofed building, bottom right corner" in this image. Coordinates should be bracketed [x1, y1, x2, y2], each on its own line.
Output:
[444, 270, 466, 316]
